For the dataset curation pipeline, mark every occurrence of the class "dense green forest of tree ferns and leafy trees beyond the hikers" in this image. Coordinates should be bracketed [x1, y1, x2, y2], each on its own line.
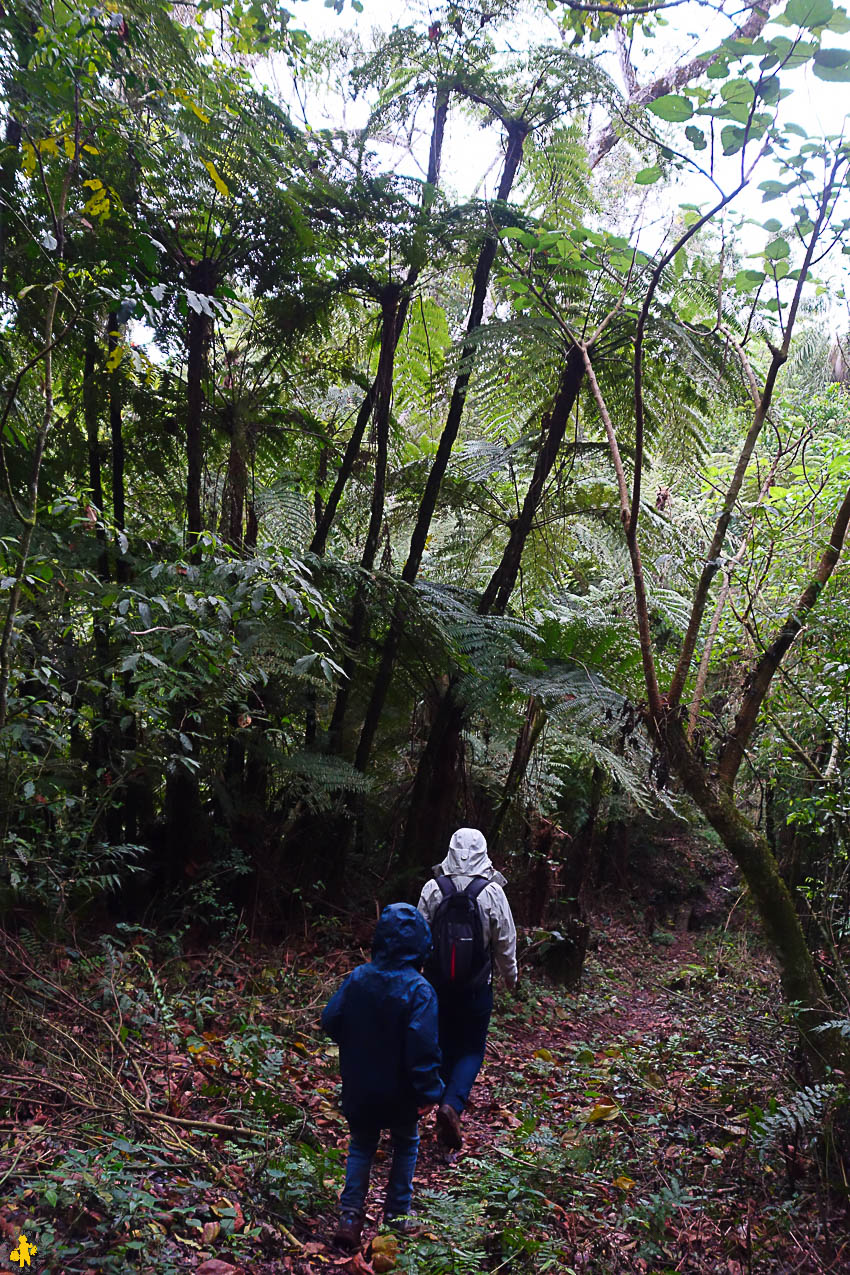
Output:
[0, 0, 850, 1270]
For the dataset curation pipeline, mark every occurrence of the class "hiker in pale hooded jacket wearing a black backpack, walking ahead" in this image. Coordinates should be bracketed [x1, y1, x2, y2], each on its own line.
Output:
[418, 827, 517, 1151]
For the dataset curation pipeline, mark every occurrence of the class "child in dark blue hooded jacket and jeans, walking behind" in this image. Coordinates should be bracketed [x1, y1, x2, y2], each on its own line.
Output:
[321, 903, 443, 1250]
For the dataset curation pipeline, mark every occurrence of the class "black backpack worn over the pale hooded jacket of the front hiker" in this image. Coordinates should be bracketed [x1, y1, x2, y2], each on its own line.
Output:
[426, 876, 491, 992]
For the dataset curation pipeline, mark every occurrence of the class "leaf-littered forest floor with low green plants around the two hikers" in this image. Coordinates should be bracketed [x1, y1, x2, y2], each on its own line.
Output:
[0, 915, 850, 1275]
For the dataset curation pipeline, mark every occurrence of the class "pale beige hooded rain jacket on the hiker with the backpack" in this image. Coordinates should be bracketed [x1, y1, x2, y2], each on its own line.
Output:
[418, 827, 516, 987]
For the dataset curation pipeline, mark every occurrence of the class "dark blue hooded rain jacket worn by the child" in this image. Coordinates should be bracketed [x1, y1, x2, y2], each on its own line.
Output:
[321, 903, 443, 1128]
